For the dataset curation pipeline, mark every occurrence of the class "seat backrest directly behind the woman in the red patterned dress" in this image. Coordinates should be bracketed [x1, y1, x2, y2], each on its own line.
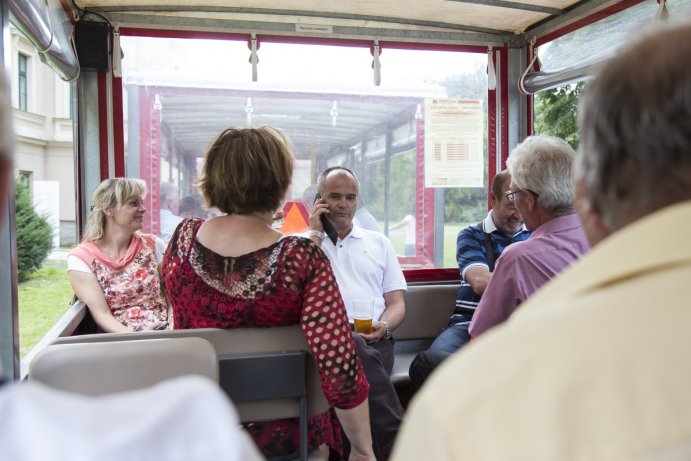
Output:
[48, 325, 329, 459]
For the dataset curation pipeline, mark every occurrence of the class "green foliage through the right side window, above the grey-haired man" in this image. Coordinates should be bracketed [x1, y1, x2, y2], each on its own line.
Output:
[535, 82, 585, 149]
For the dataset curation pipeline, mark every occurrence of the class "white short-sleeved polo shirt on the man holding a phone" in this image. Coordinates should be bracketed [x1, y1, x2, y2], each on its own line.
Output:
[321, 226, 408, 322]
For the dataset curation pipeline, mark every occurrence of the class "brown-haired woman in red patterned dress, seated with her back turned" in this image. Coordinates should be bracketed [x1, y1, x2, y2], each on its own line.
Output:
[161, 127, 375, 461]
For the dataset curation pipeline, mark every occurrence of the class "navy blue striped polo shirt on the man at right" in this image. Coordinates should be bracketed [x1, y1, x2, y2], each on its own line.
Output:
[449, 211, 530, 325]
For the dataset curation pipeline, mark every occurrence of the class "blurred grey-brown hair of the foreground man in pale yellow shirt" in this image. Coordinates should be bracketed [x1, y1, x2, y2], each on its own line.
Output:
[577, 22, 691, 231]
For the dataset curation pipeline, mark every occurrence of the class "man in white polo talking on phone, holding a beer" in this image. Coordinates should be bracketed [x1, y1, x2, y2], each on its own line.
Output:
[310, 167, 407, 460]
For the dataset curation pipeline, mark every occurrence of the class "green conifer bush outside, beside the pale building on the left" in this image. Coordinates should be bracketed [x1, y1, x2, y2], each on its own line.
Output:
[15, 181, 53, 282]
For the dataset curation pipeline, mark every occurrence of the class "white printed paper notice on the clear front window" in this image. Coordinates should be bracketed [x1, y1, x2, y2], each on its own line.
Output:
[425, 98, 485, 187]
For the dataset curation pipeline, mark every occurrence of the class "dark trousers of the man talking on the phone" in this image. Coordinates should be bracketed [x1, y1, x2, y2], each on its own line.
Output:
[353, 333, 403, 461]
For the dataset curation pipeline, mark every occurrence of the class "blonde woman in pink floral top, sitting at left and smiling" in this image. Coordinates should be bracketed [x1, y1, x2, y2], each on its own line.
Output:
[67, 178, 169, 332]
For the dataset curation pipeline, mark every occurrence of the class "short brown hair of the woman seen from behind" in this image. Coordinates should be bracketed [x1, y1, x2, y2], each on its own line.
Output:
[198, 126, 294, 214]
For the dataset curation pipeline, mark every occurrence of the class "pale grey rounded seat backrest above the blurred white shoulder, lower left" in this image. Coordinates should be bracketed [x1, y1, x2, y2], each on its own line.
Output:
[29, 335, 218, 396]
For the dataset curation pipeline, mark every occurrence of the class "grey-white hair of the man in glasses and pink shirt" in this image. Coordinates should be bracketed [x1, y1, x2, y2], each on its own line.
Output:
[506, 136, 576, 216]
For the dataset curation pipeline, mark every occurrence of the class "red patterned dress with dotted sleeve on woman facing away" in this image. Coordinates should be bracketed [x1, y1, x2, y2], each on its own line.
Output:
[161, 218, 369, 457]
